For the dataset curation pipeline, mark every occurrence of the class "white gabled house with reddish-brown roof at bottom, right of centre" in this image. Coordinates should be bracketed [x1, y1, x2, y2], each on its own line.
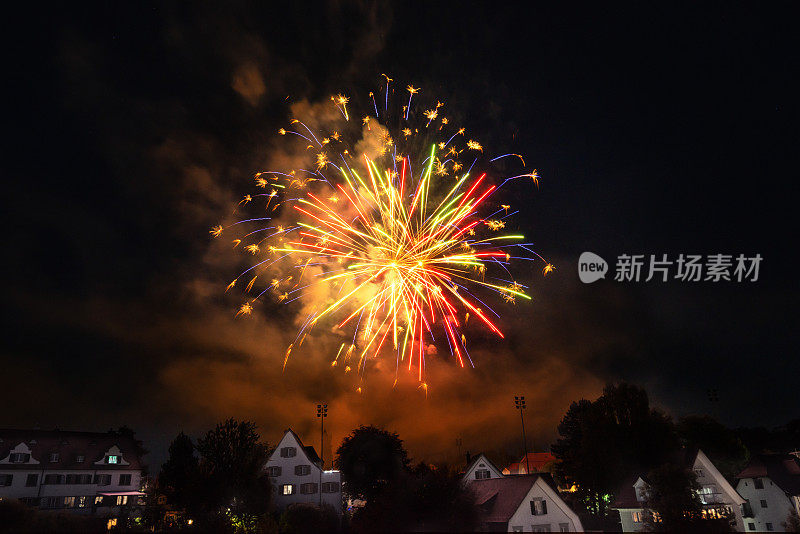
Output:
[467, 473, 583, 532]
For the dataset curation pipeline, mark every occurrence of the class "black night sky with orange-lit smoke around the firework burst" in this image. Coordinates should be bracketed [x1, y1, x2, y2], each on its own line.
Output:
[0, 2, 800, 463]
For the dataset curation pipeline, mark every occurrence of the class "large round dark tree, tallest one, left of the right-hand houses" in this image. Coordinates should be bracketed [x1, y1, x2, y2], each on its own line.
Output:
[551, 383, 678, 516]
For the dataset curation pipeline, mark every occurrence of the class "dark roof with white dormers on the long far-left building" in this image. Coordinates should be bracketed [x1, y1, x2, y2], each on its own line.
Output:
[0, 429, 142, 470]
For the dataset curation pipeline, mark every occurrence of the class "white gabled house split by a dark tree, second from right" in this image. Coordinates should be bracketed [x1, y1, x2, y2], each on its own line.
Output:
[611, 449, 745, 532]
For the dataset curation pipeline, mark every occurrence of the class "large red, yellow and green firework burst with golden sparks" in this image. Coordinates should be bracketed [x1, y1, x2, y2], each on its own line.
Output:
[211, 75, 554, 392]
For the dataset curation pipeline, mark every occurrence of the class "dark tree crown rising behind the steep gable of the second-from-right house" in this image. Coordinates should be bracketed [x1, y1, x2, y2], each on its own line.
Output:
[676, 415, 750, 480]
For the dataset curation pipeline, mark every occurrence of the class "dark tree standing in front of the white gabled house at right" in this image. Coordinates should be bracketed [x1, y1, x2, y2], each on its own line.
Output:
[645, 464, 732, 532]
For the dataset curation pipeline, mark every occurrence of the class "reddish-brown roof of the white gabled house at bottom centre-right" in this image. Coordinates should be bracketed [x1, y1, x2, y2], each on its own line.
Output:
[468, 473, 558, 523]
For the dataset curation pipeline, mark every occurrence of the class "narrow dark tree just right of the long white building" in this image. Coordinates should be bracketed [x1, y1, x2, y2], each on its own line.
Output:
[158, 432, 200, 509]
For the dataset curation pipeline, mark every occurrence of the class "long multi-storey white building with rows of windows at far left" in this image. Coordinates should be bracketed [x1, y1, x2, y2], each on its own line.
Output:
[0, 429, 144, 517]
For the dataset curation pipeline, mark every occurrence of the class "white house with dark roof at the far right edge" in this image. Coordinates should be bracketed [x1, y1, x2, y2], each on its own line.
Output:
[736, 454, 800, 532]
